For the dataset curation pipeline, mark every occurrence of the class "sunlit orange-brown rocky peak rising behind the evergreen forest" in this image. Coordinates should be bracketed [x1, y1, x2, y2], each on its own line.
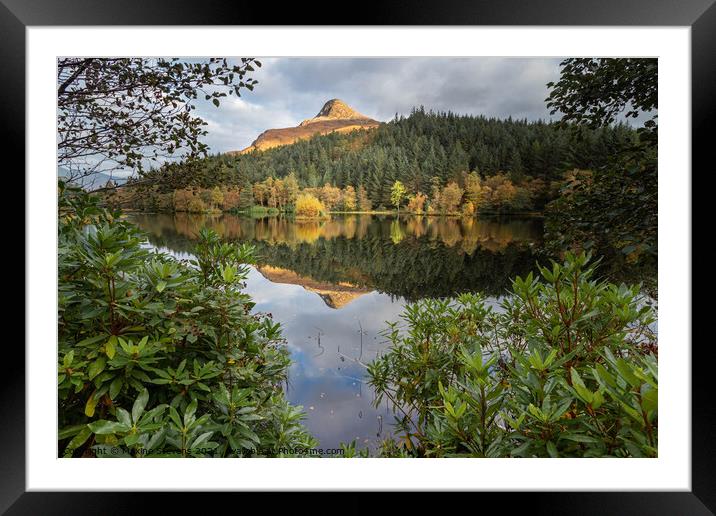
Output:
[228, 99, 380, 155]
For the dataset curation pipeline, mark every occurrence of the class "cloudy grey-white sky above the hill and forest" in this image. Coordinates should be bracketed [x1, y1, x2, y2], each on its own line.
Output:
[197, 57, 560, 153]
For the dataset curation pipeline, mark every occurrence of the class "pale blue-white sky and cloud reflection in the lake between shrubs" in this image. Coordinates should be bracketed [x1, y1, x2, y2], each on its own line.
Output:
[246, 269, 403, 447]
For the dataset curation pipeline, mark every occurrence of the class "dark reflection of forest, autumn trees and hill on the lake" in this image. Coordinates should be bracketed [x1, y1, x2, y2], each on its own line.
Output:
[132, 214, 542, 302]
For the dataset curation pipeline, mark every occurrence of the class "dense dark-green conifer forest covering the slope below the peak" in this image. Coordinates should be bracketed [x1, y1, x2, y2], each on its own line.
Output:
[134, 107, 636, 209]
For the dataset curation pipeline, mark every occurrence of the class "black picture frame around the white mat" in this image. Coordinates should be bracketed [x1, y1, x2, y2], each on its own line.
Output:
[0, 0, 716, 515]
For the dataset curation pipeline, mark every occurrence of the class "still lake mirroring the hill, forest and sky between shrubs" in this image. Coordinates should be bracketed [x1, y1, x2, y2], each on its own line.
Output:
[128, 213, 543, 449]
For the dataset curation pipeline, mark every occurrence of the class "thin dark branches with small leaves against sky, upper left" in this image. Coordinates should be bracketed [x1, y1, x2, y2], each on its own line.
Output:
[57, 57, 261, 177]
